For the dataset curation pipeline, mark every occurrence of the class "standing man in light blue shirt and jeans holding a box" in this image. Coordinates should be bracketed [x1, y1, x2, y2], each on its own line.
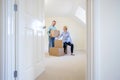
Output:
[48, 20, 57, 48]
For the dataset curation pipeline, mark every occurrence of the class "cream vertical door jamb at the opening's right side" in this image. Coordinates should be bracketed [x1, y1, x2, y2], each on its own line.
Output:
[86, 0, 94, 80]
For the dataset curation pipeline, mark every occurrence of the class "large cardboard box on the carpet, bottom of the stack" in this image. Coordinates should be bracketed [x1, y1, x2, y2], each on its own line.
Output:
[49, 48, 64, 56]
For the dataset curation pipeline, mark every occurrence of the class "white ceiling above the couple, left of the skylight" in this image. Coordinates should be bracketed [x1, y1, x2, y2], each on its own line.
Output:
[45, 0, 86, 17]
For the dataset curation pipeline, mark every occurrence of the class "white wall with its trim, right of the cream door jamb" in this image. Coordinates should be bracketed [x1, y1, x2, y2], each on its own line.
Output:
[94, 0, 120, 80]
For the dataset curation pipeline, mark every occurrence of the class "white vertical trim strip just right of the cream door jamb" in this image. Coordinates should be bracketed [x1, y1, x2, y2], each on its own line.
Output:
[93, 0, 101, 80]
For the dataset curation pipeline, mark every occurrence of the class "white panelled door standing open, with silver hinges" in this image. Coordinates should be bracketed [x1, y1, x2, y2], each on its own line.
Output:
[16, 0, 45, 80]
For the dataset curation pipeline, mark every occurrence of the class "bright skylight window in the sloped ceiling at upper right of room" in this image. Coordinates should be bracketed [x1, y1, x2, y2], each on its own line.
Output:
[75, 6, 86, 24]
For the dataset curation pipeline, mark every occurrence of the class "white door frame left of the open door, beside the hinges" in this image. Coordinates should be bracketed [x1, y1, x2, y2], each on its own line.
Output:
[0, 0, 16, 80]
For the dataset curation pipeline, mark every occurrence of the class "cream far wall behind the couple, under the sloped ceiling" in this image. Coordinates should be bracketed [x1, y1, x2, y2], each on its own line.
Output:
[45, 17, 86, 50]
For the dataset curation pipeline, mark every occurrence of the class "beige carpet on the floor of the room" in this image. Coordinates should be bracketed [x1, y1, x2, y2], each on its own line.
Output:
[36, 52, 86, 80]
